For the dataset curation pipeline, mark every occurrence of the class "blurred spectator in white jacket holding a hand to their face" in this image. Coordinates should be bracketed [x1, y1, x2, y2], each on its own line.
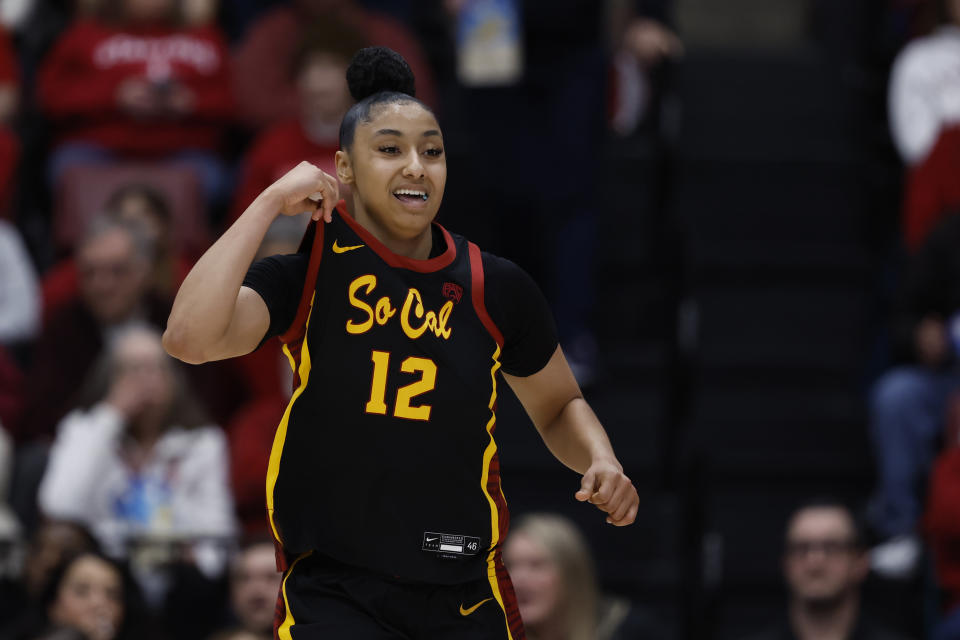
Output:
[39, 326, 234, 568]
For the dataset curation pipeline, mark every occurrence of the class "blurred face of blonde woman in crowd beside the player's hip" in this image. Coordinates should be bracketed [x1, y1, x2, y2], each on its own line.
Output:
[503, 532, 563, 627]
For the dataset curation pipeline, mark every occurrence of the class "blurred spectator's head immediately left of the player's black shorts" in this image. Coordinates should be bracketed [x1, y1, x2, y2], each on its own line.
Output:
[224, 538, 282, 640]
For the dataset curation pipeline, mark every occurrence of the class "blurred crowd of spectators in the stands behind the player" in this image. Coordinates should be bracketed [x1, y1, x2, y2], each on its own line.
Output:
[0, 0, 960, 640]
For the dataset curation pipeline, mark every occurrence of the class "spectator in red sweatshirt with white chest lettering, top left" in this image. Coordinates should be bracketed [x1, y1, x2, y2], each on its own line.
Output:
[38, 0, 233, 200]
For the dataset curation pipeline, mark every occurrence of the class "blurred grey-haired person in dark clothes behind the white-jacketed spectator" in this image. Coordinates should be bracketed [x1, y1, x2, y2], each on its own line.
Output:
[14, 218, 159, 441]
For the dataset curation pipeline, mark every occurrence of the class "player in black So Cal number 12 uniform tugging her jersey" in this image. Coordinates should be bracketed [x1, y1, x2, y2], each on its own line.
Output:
[164, 48, 638, 640]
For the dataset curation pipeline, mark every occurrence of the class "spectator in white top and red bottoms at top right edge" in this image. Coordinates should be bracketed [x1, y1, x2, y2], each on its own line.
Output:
[889, 0, 960, 251]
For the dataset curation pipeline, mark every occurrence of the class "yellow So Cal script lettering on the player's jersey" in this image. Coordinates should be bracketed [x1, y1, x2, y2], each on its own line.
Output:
[347, 274, 453, 340]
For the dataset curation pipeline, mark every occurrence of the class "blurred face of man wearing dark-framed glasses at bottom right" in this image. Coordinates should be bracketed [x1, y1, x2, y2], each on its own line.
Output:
[784, 508, 869, 603]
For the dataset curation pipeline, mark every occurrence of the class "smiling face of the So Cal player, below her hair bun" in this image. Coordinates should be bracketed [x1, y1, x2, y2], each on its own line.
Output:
[337, 102, 447, 245]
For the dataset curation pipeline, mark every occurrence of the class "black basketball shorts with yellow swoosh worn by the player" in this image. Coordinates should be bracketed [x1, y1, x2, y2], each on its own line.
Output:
[274, 552, 525, 640]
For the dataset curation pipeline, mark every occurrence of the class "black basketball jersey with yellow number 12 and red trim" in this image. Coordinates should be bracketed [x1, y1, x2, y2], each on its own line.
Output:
[267, 203, 508, 584]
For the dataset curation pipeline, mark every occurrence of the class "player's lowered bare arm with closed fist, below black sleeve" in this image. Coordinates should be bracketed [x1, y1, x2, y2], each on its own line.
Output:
[503, 346, 640, 526]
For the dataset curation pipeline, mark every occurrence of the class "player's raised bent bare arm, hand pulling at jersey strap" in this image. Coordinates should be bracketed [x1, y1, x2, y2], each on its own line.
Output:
[163, 162, 339, 364]
